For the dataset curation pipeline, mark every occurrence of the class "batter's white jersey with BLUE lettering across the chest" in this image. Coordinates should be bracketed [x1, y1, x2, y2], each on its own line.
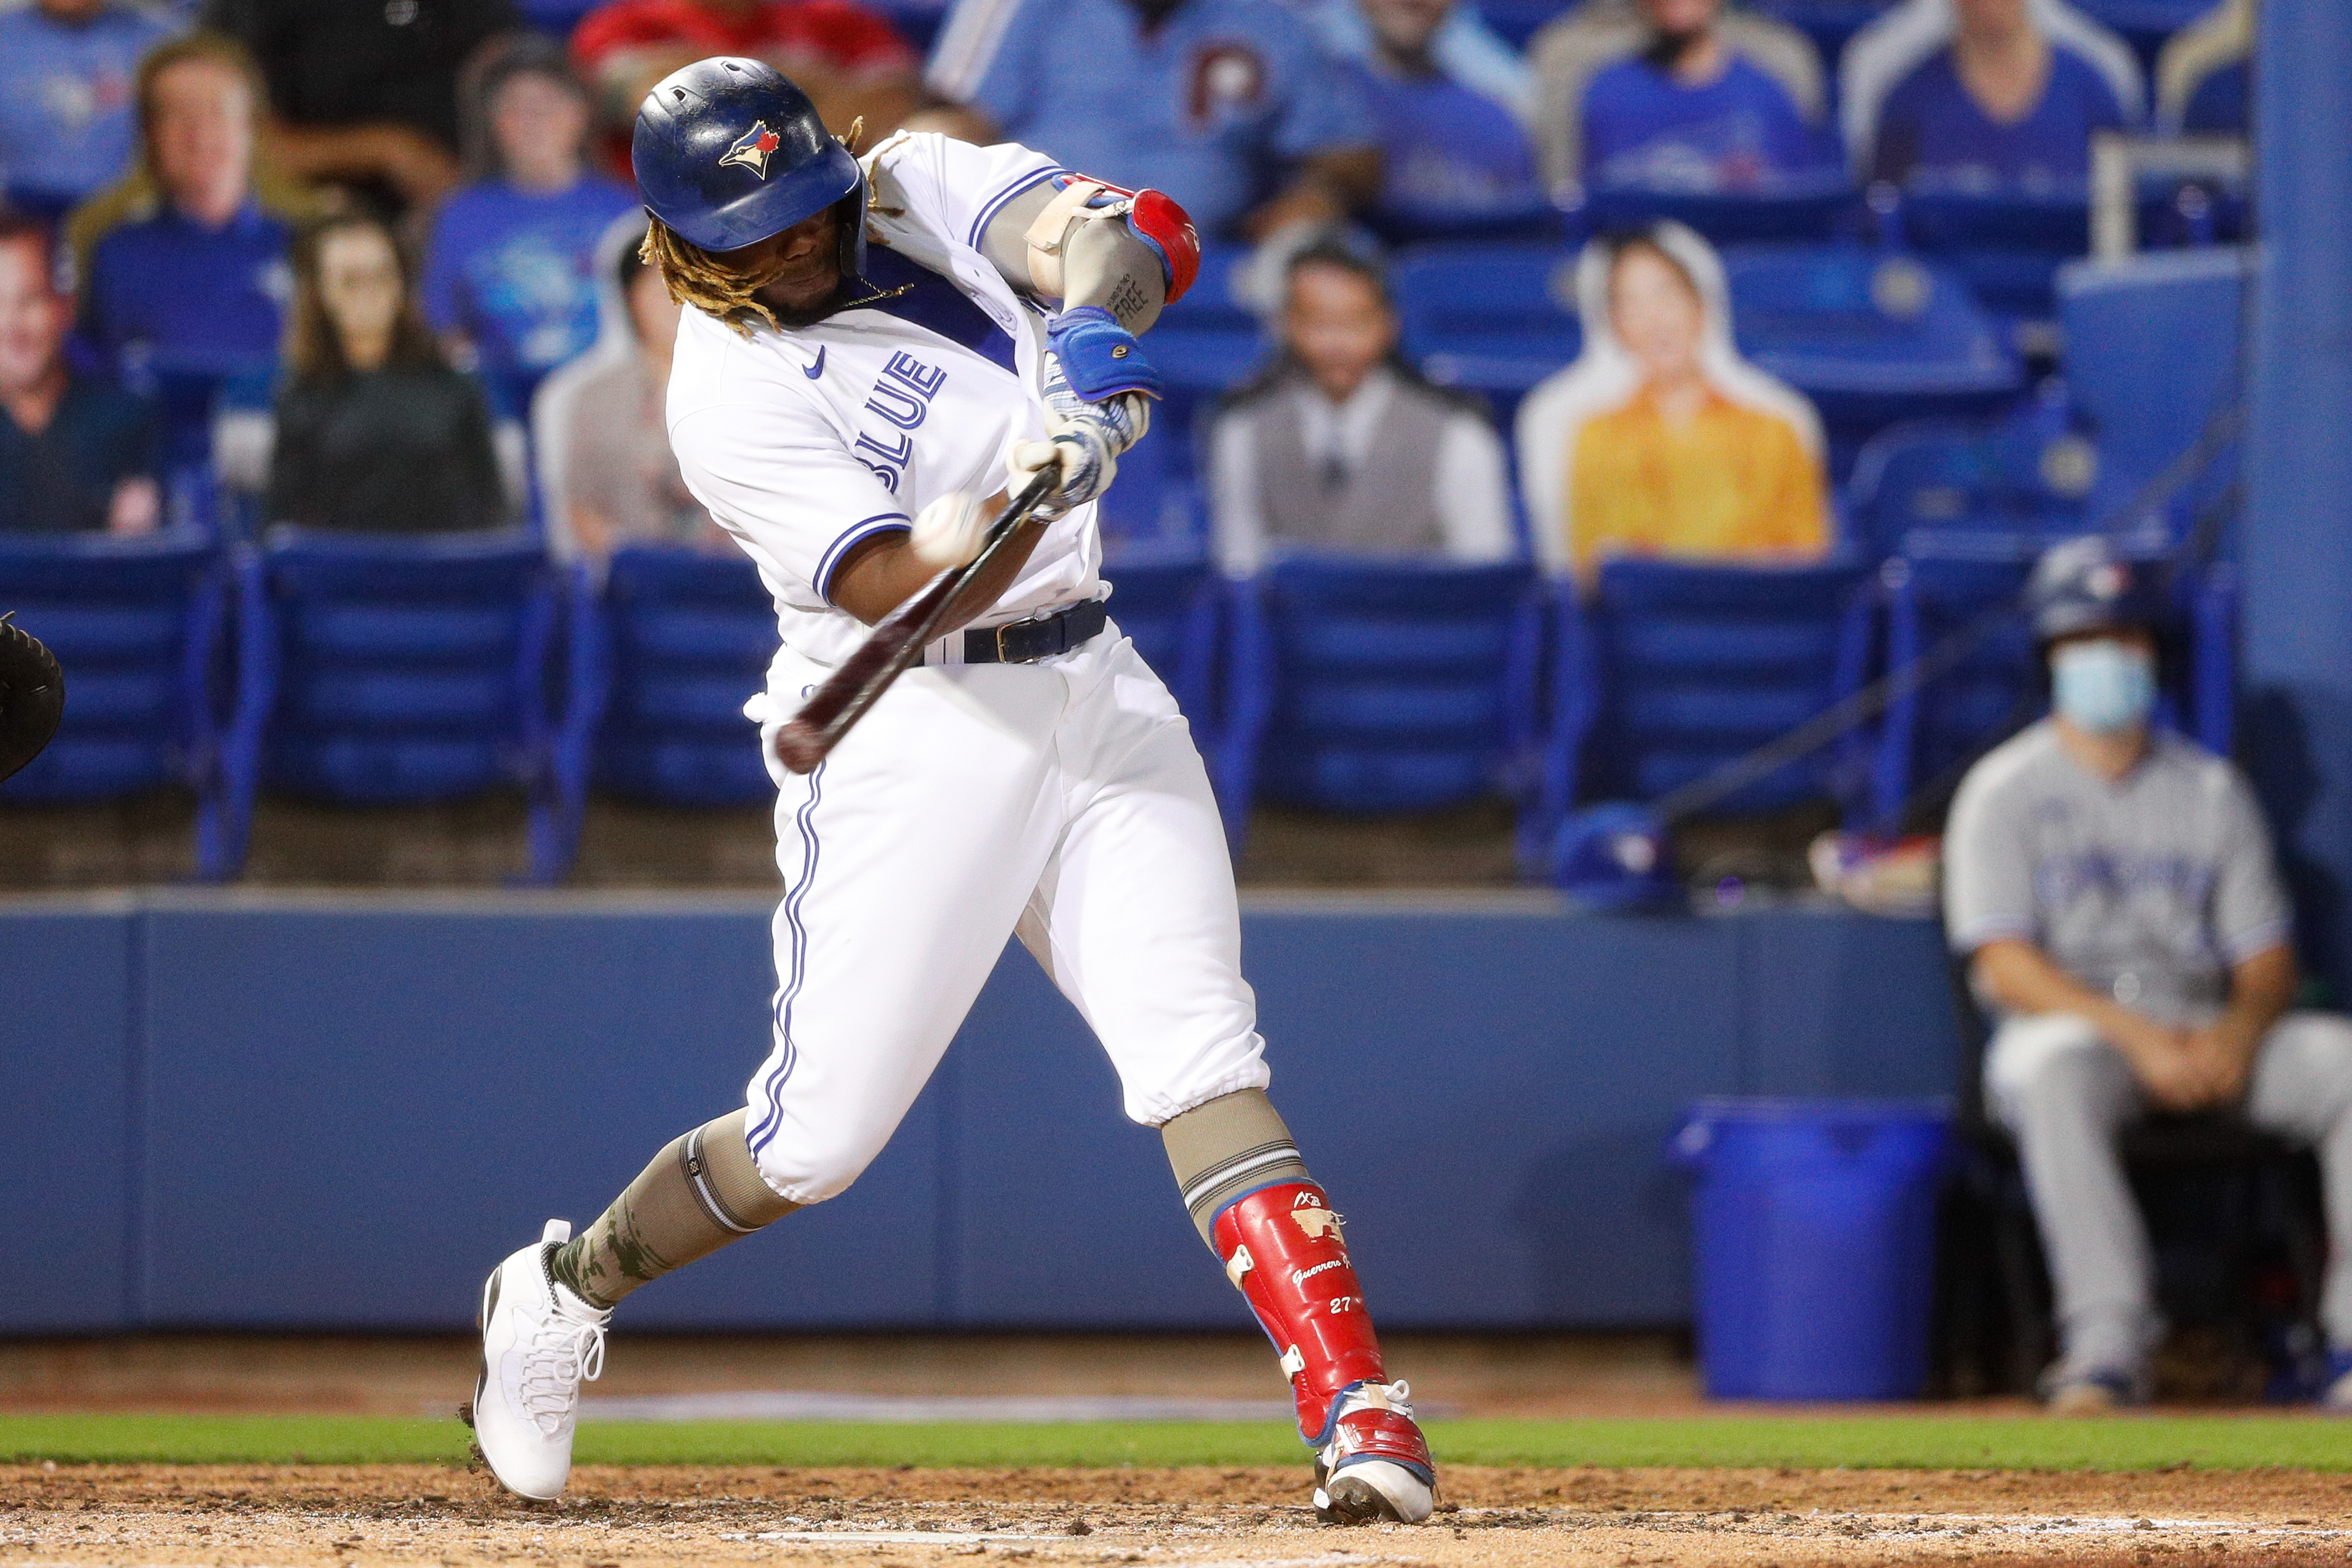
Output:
[668, 134, 1103, 663]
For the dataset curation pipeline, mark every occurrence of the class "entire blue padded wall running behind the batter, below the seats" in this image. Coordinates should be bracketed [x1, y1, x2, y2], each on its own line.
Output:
[0, 893, 1952, 1333]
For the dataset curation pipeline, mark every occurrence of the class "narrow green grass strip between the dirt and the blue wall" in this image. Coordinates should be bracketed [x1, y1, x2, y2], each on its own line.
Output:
[0, 1415, 2352, 1469]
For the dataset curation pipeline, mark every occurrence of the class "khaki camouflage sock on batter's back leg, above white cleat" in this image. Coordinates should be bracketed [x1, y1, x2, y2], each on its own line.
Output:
[548, 1110, 800, 1307]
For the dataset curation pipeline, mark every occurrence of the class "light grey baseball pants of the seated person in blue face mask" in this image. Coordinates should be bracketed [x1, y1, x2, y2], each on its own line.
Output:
[1985, 1013, 2352, 1373]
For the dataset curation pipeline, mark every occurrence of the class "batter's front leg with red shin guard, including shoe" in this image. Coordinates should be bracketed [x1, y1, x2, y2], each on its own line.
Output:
[1021, 642, 1435, 1523]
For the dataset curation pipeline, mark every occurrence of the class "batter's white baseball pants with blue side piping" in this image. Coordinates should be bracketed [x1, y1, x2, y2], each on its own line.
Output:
[746, 626, 1268, 1204]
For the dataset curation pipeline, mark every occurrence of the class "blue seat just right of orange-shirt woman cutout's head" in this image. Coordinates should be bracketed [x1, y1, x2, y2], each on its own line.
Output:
[1724, 244, 2025, 475]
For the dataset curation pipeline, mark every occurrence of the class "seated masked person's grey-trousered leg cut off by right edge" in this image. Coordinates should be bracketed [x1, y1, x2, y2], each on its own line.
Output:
[2246, 1013, 2352, 1413]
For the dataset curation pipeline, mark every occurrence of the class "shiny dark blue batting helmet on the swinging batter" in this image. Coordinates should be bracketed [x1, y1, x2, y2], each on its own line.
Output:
[628, 54, 866, 266]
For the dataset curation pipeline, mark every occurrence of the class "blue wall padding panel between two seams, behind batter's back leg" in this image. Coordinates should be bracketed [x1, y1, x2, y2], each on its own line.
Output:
[143, 901, 938, 1328]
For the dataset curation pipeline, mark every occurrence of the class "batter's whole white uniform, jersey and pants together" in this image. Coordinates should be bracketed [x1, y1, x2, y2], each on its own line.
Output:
[671, 134, 1268, 1204]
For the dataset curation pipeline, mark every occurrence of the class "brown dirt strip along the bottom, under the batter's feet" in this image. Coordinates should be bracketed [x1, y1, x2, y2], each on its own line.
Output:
[0, 1465, 2352, 1568]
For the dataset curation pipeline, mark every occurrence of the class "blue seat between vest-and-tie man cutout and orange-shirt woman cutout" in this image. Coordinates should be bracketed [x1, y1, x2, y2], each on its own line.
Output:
[1390, 244, 1585, 402]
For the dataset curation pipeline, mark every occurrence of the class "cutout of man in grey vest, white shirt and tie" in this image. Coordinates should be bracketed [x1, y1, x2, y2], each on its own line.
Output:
[1209, 242, 1517, 576]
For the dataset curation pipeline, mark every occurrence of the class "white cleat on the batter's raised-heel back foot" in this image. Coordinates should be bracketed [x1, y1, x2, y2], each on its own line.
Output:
[472, 1220, 612, 1502]
